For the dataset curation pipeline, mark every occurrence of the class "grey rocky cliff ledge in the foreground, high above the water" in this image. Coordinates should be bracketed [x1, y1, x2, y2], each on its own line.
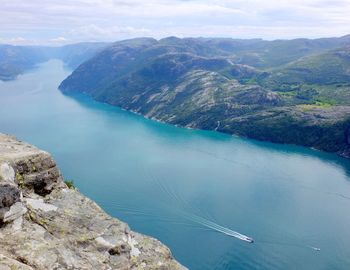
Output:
[0, 134, 185, 270]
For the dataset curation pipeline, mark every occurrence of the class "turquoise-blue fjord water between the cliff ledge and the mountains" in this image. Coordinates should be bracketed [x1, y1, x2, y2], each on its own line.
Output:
[0, 60, 350, 270]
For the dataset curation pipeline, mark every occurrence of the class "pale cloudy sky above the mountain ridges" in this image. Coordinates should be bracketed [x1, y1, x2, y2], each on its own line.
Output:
[0, 0, 350, 45]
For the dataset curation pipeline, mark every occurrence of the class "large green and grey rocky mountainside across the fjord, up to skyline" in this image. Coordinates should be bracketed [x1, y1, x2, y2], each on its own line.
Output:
[60, 36, 350, 156]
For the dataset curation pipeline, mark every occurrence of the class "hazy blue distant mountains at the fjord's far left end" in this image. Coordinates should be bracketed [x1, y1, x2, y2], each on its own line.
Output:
[0, 43, 107, 80]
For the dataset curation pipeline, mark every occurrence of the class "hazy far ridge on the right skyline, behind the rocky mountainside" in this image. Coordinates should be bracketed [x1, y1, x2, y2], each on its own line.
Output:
[154, 35, 350, 68]
